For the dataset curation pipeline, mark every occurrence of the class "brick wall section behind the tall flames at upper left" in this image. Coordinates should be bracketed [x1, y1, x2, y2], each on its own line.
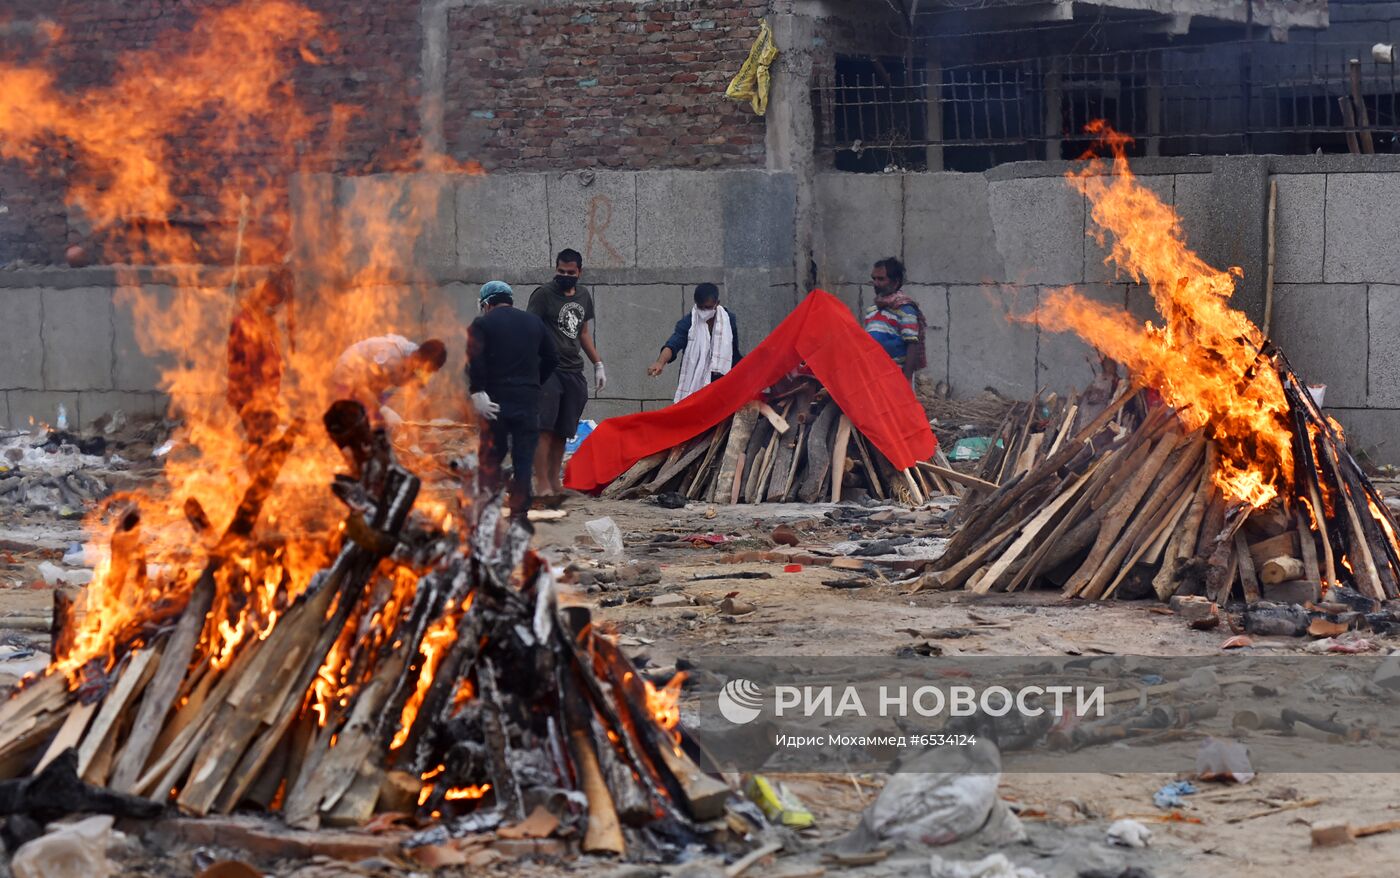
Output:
[0, 0, 421, 265]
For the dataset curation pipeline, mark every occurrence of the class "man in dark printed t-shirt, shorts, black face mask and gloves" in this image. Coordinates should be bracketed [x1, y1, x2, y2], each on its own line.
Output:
[526, 249, 608, 506]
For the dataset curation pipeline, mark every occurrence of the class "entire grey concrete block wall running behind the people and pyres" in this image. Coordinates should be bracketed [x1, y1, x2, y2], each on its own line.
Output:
[16, 155, 1400, 462]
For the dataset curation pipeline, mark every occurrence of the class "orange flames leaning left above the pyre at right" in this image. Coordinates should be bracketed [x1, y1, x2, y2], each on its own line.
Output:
[1035, 122, 1294, 507]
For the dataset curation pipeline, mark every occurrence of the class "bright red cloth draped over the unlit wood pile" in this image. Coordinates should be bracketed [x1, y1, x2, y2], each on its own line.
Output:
[564, 290, 938, 493]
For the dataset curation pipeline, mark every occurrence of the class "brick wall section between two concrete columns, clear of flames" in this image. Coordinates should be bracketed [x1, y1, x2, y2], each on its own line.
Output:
[445, 0, 767, 171]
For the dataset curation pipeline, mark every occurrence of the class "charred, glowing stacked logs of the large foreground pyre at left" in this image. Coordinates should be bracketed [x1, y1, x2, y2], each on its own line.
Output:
[0, 403, 729, 853]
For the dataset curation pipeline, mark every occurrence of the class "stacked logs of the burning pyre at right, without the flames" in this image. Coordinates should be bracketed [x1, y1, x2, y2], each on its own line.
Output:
[920, 351, 1400, 602]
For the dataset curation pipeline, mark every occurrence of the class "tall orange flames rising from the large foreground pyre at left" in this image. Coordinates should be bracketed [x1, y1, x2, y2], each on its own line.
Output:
[0, 0, 477, 677]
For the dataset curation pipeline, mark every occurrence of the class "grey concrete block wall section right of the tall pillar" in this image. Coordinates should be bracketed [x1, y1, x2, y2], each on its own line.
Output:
[813, 155, 1400, 464]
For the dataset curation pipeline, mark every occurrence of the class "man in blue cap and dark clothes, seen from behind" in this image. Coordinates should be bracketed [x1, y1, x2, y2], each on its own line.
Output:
[466, 280, 559, 524]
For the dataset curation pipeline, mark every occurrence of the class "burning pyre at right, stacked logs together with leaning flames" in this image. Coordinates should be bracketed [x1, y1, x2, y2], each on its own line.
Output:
[924, 127, 1400, 606]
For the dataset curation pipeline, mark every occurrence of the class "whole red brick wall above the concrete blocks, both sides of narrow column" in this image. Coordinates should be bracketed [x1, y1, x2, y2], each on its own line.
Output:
[0, 0, 769, 266]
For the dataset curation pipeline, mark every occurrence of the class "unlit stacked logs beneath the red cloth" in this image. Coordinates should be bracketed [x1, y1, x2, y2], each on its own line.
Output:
[603, 378, 967, 506]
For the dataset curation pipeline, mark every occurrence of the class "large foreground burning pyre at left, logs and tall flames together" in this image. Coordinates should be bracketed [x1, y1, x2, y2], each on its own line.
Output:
[0, 0, 728, 853]
